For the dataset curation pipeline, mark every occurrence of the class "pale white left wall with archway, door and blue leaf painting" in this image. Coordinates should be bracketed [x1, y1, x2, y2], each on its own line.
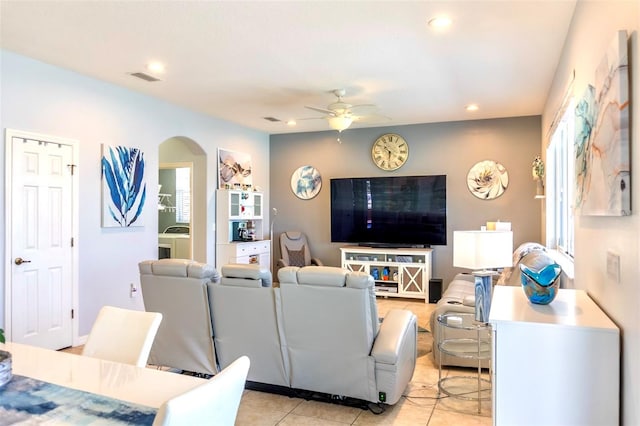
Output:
[0, 50, 269, 336]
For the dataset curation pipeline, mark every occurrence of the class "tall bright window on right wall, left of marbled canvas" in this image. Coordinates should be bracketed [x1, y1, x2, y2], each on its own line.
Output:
[546, 100, 575, 258]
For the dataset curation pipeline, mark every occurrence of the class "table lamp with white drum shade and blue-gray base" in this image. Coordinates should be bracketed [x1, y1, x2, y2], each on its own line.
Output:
[453, 231, 513, 323]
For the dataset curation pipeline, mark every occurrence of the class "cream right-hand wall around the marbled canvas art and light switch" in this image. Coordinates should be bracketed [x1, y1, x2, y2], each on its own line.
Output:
[542, 0, 640, 425]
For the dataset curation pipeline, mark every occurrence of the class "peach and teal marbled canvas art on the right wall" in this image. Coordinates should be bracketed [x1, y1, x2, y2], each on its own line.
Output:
[574, 31, 631, 216]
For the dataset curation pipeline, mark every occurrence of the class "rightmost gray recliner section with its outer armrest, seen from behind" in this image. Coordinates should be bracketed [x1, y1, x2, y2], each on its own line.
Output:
[278, 266, 417, 404]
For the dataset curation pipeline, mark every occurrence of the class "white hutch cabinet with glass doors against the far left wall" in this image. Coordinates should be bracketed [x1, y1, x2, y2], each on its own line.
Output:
[216, 189, 271, 270]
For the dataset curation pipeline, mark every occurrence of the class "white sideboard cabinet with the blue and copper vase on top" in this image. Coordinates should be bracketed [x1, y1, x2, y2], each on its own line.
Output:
[489, 286, 620, 426]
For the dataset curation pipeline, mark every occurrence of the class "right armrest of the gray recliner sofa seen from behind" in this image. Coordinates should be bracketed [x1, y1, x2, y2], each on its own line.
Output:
[371, 309, 417, 365]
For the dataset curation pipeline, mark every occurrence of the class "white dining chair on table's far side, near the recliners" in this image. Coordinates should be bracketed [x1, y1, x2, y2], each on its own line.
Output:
[82, 306, 162, 367]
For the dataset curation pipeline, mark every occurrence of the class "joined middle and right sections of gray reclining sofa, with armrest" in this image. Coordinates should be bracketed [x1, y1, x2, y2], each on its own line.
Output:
[209, 265, 417, 404]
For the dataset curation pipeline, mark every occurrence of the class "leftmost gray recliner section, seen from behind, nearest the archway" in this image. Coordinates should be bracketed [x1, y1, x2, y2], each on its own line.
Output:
[138, 259, 220, 374]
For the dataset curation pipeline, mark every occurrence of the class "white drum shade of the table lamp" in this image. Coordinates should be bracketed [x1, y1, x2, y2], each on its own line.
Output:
[453, 231, 513, 270]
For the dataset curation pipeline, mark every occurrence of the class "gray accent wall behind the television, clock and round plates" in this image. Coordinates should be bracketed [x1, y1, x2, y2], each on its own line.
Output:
[270, 116, 542, 285]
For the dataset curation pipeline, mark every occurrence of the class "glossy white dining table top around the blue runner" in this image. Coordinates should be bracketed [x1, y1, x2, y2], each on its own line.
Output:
[0, 342, 206, 408]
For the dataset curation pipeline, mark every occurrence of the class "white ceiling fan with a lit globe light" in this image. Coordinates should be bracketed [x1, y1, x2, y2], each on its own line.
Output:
[305, 89, 391, 132]
